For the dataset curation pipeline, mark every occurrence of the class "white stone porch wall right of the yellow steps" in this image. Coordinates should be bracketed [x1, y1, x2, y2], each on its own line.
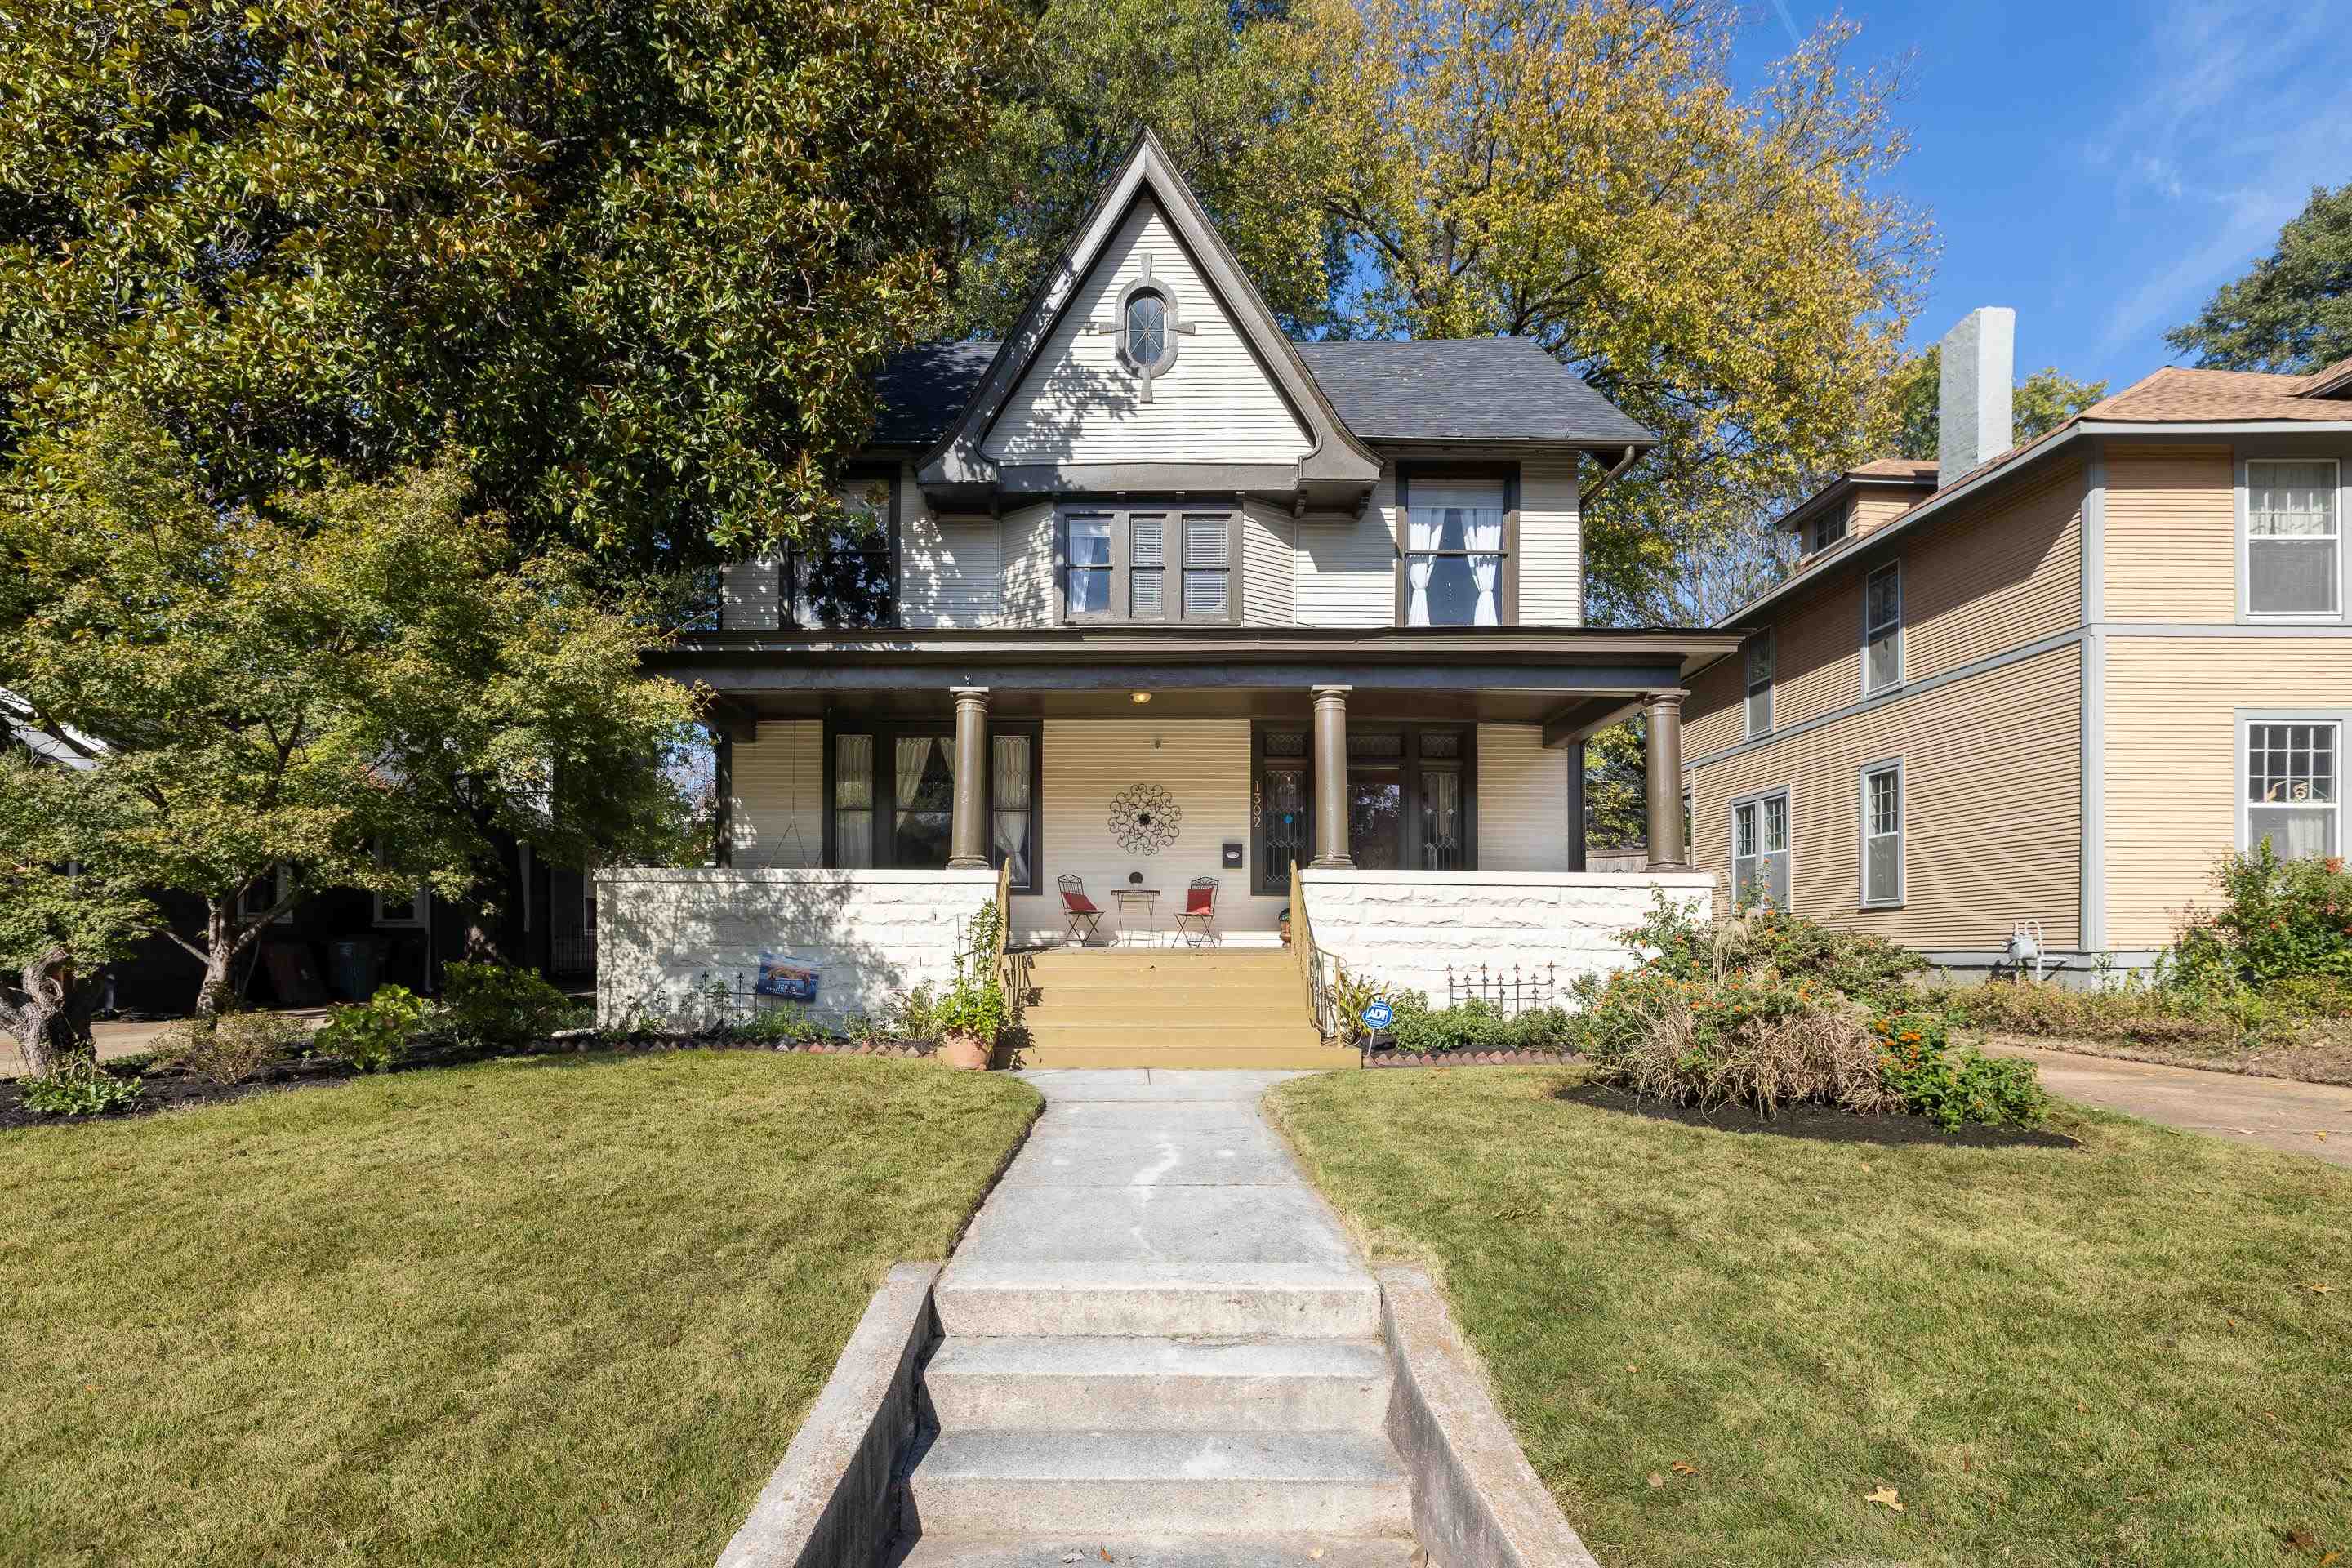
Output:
[1303, 870, 1715, 1006]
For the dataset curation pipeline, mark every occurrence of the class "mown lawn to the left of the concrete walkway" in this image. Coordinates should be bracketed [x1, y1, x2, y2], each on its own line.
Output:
[0, 1051, 1037, 1568]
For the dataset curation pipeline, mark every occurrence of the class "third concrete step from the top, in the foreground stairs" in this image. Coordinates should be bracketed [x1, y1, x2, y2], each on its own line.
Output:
[908, 1432, 1414, 1561]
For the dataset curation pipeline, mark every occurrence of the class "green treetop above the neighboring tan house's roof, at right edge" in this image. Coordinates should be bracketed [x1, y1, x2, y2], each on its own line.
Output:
[2164, 184, 2352, 374]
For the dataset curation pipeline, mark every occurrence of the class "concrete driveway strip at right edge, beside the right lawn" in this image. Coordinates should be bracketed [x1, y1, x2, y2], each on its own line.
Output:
[1985, 1044, 2352, 1166]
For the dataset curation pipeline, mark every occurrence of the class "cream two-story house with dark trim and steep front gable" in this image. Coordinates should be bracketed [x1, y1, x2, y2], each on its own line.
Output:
[597, 136, 1738, 1048]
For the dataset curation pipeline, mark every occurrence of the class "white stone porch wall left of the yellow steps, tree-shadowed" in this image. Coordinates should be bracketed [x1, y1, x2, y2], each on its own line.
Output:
[595, 870, 997, 1027]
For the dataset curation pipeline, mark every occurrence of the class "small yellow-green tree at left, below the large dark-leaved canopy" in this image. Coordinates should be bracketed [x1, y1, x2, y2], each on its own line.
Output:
[0, 416, 694, 1011]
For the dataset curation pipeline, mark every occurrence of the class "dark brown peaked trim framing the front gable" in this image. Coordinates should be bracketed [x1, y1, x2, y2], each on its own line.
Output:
[917, 131, 1381, 503]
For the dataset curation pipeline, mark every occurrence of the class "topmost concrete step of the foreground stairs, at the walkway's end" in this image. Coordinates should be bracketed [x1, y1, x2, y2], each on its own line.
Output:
[931, 1258, 1381, 1340]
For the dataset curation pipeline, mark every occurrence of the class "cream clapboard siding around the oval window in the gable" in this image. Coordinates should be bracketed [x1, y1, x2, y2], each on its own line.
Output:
[983, 200, 1307, 463]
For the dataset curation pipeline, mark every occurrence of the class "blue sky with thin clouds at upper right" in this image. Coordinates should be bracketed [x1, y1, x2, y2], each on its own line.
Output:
[1740, 0, 2352, 388]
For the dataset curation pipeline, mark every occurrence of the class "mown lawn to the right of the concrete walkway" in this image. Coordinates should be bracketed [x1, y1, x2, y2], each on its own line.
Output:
[1272, 1067, 2352, 1568]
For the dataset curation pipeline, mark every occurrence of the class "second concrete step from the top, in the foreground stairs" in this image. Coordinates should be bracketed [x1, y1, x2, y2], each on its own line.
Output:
[922, 1335, 1392, 1432]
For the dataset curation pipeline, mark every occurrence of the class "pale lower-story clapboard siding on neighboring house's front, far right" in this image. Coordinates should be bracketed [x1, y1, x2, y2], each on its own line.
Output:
[2105, 632, 2352, 947]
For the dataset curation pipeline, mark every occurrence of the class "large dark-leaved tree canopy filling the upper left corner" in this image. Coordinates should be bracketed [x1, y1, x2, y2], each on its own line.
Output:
[0, 0, 1021, 559]
